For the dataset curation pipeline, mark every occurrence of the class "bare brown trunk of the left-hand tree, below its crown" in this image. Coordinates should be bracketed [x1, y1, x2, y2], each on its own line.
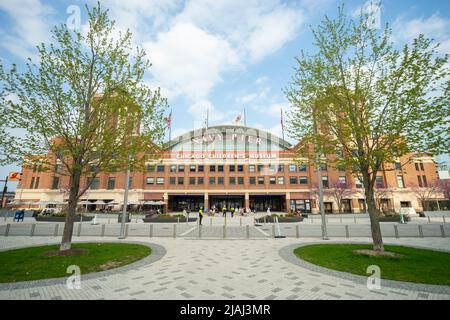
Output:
[59, 171, 81, 251]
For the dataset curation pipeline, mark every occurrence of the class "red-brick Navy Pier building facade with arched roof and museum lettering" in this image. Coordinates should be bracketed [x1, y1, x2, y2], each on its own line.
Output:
[16, 125, 441, 213]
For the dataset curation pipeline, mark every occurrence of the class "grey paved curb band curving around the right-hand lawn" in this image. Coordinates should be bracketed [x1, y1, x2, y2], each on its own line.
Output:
[278, 241, 450, 296]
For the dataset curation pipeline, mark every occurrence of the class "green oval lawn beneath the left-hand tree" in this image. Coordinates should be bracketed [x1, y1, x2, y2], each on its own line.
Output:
[0, 243, 152, 283]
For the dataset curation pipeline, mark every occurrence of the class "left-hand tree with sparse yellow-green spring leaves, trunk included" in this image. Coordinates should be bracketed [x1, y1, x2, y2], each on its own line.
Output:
[0, 3, 167, 250]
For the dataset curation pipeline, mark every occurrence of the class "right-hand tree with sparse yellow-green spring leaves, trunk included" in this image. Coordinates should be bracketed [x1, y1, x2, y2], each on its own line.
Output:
[285, 3, 450, 251]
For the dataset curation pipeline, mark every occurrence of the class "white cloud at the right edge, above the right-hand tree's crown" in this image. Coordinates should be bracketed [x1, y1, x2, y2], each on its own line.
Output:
[392, 13, 450, 53]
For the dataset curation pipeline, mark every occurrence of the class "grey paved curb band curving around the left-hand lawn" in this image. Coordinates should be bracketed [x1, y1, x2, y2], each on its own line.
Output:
[0, 240, 167, 291]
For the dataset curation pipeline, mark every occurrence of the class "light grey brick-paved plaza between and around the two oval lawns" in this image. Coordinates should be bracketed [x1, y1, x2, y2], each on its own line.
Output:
[0, 236, 450, 300]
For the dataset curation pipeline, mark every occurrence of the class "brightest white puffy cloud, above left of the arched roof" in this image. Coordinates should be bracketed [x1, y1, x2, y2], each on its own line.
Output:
[144, 23, 239, 101]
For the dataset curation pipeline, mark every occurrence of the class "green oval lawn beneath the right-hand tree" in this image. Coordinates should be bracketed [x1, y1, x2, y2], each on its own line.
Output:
[294, 244, 450, 286]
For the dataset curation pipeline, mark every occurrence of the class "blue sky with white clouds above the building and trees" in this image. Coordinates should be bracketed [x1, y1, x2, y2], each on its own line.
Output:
[0, 0, 450, 189]
